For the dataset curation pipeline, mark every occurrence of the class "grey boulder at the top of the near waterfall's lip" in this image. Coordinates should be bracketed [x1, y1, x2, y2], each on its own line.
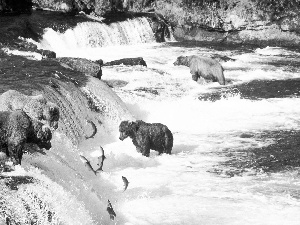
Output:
[55, 57, 102, 79]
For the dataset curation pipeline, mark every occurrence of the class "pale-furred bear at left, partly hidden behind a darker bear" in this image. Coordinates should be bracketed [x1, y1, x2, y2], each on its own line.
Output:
[0, 90, 59, 129]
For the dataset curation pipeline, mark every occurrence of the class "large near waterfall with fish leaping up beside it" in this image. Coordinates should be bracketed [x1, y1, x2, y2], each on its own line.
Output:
[0, 77, 133, 225]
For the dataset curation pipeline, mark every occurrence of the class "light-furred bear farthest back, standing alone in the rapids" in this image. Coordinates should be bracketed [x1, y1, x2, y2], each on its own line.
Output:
[174, 55, 225, 85]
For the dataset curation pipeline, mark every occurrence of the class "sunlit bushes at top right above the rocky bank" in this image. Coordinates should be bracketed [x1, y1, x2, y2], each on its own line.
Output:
[157, 0, 300, 28]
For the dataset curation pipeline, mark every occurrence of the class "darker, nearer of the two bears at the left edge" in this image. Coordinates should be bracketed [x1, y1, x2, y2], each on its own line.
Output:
[0, 110, 52, 164]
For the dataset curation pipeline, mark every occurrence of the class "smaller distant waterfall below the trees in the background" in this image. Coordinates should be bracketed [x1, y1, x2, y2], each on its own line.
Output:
[41, 17, 155, 51]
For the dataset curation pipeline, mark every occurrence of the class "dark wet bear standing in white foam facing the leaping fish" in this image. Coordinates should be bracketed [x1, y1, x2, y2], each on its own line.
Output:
[119, 120, 173, 157]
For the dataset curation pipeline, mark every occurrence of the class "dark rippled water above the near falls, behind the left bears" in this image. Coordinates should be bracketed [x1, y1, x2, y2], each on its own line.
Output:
[0, 49, 88, 95]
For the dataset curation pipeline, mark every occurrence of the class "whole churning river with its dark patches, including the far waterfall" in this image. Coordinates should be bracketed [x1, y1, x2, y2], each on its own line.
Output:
[1, 16, 300, 225]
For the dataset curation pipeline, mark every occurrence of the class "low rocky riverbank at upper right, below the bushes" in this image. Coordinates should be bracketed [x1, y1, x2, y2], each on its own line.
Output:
[174, 15, 300, 47]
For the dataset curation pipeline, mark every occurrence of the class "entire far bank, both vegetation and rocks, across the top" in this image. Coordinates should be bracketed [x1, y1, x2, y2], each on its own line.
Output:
[0, 0, 300, 47]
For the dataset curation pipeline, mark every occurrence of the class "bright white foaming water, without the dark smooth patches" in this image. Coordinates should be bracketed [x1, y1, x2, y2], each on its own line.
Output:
[2, 18, 300, 225]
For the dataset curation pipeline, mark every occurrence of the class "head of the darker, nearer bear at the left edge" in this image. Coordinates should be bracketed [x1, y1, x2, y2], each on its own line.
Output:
[27, 120, 52, 150]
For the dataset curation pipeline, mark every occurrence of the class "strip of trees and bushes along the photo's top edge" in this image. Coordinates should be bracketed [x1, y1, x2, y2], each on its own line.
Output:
[0, 0, 300, 28]
